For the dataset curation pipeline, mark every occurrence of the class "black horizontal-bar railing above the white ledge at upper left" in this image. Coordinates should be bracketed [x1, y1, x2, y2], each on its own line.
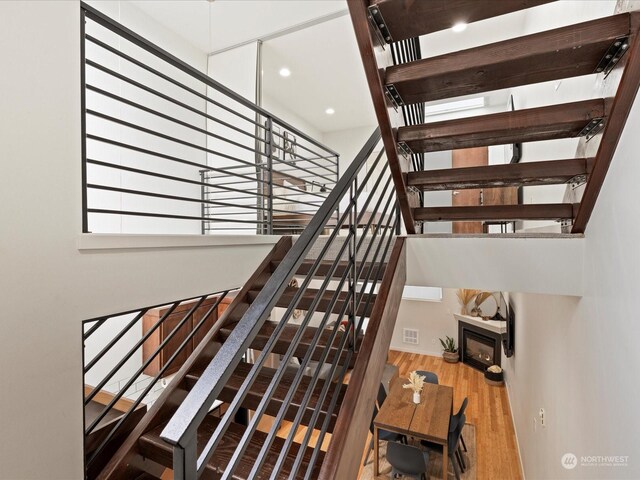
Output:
[81, 4, 338, 234]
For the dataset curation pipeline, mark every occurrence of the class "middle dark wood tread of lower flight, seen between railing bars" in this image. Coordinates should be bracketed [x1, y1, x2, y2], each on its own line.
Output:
[220, 321, 362, 366]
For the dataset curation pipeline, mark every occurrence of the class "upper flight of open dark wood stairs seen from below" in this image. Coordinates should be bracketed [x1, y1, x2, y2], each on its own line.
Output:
[349, 0, 640, 233]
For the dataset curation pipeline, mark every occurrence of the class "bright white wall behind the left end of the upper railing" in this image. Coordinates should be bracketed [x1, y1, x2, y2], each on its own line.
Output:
[85, 2, 206, 233]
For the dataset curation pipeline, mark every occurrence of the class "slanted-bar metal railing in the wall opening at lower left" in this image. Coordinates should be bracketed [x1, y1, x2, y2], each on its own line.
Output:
[82, 290, 236, 478]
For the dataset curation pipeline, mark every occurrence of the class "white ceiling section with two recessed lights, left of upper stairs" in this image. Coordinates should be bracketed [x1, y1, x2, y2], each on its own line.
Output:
[262, 16, 377, 132]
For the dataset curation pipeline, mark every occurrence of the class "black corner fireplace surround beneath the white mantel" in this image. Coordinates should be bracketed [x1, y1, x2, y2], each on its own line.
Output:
[458, 321, 502, 372]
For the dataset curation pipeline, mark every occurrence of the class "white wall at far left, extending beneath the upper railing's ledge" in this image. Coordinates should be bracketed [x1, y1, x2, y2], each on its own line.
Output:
[0, 1, 278, 480]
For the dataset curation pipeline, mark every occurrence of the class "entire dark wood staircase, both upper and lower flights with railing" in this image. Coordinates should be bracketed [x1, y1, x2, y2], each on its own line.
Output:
[87, 0, 640, 480]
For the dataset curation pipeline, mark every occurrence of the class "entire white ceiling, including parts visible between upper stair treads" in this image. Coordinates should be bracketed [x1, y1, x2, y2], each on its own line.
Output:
[122, 0, 616, 132]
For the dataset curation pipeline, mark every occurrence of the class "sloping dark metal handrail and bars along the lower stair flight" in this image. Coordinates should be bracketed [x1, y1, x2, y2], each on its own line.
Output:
[161, 130, 400, 480]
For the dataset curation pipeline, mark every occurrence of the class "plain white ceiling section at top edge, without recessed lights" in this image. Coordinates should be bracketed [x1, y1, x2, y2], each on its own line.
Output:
[132, 0, 347, 53]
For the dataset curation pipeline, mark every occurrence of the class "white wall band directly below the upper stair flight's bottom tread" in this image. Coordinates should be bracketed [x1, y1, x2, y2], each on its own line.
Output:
[407, 235, 588, 295]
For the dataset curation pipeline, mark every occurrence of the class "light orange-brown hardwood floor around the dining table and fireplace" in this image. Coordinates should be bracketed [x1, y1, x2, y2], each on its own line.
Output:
[388, 350, 522, 480]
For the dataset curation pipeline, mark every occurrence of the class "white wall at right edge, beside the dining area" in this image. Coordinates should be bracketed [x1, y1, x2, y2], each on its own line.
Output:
[507, 70, 640, 479]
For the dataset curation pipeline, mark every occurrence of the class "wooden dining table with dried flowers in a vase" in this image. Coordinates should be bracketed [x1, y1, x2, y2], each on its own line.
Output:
[373, 378, 453, 480]
